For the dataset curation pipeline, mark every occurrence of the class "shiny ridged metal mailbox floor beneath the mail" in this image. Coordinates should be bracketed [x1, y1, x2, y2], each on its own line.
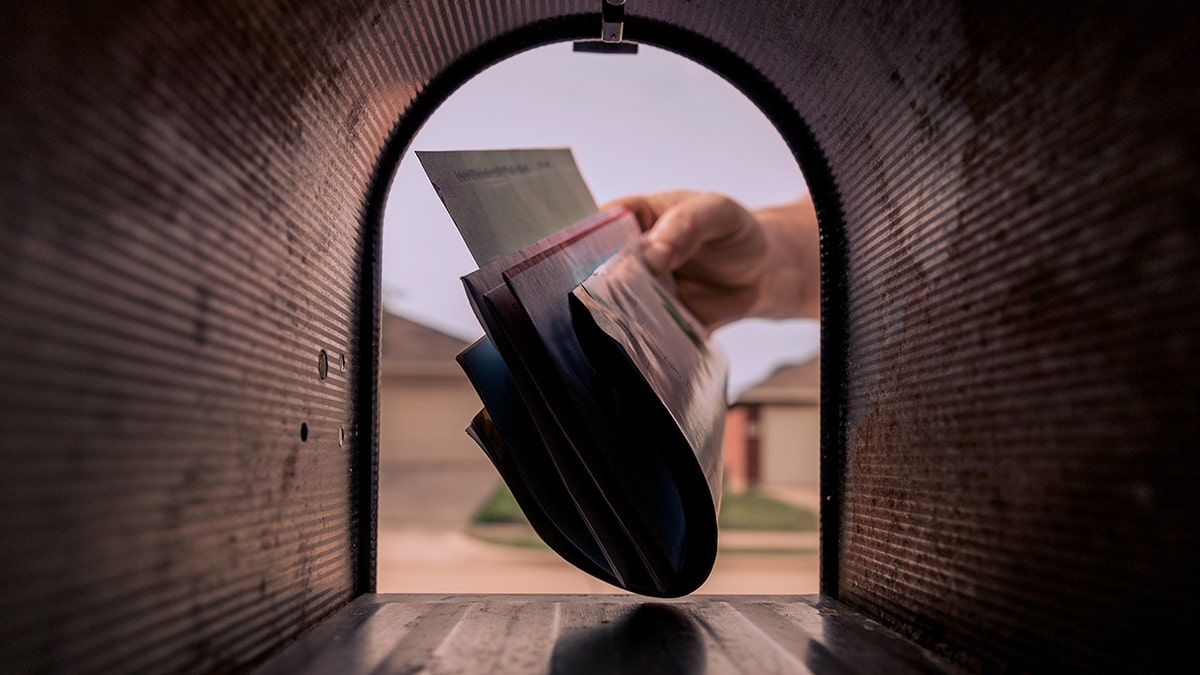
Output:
[258, 595, 944, 675]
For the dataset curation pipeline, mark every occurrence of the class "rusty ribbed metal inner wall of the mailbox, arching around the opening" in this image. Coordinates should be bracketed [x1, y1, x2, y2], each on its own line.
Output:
[0, 0, 1200, 670]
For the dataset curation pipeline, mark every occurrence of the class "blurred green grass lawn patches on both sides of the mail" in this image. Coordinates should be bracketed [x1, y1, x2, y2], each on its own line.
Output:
[473, 483, 817, 531]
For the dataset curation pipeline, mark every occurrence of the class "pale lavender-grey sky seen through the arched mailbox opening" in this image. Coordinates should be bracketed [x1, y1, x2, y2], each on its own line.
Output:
[383, 43, 818, 395]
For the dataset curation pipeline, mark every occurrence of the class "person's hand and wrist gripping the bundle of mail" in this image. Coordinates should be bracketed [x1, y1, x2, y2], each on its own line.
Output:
[605, 190, 821, 329]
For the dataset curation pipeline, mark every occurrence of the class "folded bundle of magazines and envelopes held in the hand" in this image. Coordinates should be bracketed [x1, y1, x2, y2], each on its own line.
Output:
[418, 149, 727, 597]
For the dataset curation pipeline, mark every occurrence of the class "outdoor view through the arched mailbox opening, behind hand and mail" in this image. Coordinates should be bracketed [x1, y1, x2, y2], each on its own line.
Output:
[378, 43, 820, 593]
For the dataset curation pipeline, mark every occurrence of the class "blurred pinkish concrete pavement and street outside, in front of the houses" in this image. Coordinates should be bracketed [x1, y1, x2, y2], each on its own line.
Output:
[377, 460, 820, 593]
